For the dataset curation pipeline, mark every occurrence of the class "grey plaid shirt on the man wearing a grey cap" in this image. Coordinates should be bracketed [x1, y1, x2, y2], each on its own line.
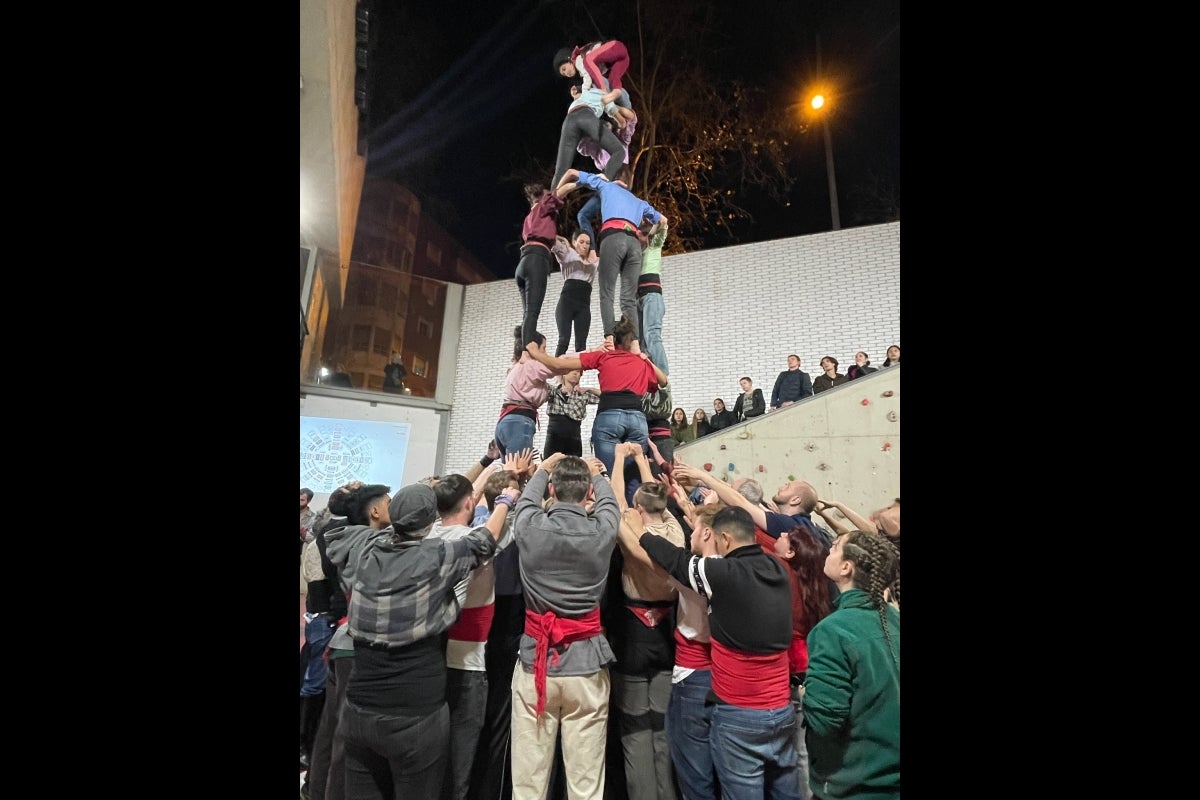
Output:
[325, 525, 496, 649]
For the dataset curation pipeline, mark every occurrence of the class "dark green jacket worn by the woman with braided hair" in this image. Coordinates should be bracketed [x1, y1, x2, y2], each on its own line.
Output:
[803, 589, 900, 800]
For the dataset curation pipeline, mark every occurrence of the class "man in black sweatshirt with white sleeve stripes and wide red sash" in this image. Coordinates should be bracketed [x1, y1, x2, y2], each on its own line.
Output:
[638, 507, 800, 800]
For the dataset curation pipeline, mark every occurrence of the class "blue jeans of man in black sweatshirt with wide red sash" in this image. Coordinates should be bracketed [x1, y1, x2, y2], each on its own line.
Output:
[709, 703, 800, 800]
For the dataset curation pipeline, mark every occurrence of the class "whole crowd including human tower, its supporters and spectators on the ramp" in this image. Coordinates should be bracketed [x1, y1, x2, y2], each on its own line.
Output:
[300, 31, 900, 800]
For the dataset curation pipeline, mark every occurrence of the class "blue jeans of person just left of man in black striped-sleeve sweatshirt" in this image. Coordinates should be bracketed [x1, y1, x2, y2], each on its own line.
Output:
[667, 669, 716, 800]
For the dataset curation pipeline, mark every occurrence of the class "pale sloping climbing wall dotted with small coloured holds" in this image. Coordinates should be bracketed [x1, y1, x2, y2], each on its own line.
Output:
[676, 366, 900, 516]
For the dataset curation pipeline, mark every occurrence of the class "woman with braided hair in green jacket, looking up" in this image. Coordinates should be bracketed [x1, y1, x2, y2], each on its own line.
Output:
[803, 530, 900, 800]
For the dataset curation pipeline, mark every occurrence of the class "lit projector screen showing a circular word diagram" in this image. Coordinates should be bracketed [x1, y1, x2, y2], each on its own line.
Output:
[300, 416, 413, 494]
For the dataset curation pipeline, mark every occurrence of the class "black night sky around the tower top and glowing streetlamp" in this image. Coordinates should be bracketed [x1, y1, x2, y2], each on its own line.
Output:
[367, 0, 900, 277]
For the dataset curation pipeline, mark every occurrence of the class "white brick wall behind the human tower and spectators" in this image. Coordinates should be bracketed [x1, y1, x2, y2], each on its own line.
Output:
[443, 222, 900, 479]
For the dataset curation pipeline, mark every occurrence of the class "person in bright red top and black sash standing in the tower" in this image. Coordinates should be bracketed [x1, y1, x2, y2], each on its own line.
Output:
[526, 317, 667, 474]
